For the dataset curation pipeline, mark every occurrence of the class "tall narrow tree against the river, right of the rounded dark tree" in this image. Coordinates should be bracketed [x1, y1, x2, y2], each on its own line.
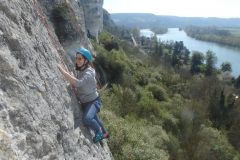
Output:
[205, 50, 217, 76]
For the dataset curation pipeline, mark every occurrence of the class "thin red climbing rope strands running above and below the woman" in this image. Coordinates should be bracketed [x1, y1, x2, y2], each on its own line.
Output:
[34, 0, 132, 160]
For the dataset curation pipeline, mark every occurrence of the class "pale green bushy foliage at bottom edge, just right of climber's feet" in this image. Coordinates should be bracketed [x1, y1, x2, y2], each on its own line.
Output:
[97, 109, 169, 160]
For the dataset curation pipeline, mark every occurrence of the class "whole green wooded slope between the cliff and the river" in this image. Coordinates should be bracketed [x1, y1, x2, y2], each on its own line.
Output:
[92, 27, 240, 160]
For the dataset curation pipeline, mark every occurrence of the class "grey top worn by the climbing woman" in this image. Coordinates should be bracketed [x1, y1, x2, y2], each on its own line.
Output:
[74, 67, 98, 103]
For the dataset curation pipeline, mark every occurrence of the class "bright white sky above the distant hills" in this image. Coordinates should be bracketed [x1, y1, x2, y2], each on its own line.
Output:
[103, 0, 240, 18]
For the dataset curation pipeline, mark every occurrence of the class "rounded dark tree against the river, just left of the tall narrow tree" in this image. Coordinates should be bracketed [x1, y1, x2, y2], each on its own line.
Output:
[190, 52, 204, 74]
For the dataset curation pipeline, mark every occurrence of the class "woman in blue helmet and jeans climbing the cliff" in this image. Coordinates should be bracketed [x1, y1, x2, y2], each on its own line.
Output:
[57, 48, 109, 142]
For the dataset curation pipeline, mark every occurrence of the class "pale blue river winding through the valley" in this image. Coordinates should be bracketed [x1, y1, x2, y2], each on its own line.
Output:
[140, 28, 240, 78]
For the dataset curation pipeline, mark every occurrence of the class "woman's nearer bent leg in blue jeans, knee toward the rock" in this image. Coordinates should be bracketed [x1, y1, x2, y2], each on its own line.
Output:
[83, 103, 100, 132]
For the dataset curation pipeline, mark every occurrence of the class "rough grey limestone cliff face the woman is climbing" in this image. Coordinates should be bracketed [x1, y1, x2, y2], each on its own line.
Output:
[0, 0, 113, 160]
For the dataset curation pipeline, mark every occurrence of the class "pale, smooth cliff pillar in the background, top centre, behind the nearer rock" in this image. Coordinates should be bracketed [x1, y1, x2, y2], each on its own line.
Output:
[80, 0, 103, 38]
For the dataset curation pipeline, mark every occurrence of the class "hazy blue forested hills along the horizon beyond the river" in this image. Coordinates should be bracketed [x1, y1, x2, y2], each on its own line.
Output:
[111, 13, 240, 28]
